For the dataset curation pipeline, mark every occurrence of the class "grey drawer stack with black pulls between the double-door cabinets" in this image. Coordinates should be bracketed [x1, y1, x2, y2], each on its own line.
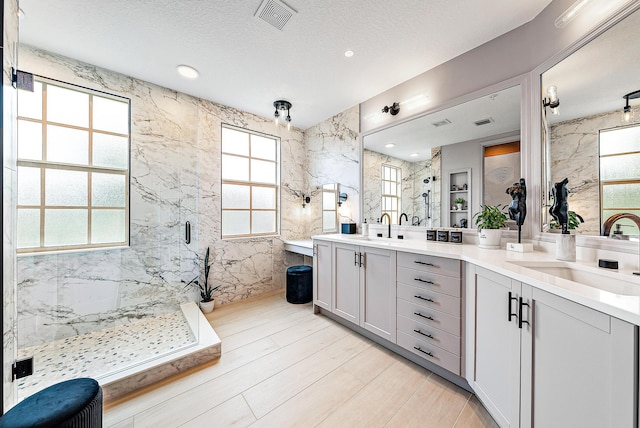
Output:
[397, 252, 462, 375]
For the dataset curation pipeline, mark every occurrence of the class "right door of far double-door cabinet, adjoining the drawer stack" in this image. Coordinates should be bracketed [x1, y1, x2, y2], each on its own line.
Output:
[360, 247, 396, 343]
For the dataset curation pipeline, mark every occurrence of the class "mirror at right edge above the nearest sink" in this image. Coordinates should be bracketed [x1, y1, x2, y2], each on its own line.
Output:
[541, 6, 640, 239]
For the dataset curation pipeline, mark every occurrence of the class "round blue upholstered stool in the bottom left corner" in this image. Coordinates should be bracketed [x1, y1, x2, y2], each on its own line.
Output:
[0, 378, 102, 428]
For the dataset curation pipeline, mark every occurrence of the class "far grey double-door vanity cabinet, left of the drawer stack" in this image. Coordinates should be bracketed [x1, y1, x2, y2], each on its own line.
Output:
[328, 242, 396, 343]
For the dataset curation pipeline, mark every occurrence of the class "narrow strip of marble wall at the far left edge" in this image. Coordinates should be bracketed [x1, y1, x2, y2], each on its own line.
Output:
[0, 0, 18, 412]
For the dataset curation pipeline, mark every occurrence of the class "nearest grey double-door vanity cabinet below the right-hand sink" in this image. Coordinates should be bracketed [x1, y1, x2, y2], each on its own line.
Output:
[466, 265, 637, 428]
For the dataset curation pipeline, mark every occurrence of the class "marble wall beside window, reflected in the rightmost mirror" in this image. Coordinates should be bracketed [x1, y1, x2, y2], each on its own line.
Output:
[550, 106, 640, 235]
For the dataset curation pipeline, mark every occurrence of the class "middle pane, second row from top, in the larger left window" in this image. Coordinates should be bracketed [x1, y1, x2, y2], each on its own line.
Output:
[47, 125, 89, 165]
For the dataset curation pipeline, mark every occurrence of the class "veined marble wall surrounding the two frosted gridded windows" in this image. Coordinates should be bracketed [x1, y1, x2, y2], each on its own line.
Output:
[17, 46, 306, 346]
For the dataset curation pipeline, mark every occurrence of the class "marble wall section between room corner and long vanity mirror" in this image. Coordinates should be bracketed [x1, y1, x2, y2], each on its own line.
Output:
[304, 106, 361, 237]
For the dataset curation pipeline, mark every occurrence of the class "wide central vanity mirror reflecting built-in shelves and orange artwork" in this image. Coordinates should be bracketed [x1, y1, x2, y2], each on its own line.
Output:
[362, 85, 521, 227]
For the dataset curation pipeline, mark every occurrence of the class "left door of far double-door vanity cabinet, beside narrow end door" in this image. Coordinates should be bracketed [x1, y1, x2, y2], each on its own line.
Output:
[331, 243, 360, 324]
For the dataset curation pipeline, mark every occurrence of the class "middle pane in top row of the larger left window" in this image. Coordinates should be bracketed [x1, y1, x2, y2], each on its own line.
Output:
[47, 85, 89, 128]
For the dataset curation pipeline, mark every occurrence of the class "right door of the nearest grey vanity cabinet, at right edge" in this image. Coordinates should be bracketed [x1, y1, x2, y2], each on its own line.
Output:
[522, 285, 637, 428]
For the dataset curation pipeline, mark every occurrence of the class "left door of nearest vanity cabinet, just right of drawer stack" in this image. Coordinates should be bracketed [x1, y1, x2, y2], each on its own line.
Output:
[467, 267, 521, 427]
